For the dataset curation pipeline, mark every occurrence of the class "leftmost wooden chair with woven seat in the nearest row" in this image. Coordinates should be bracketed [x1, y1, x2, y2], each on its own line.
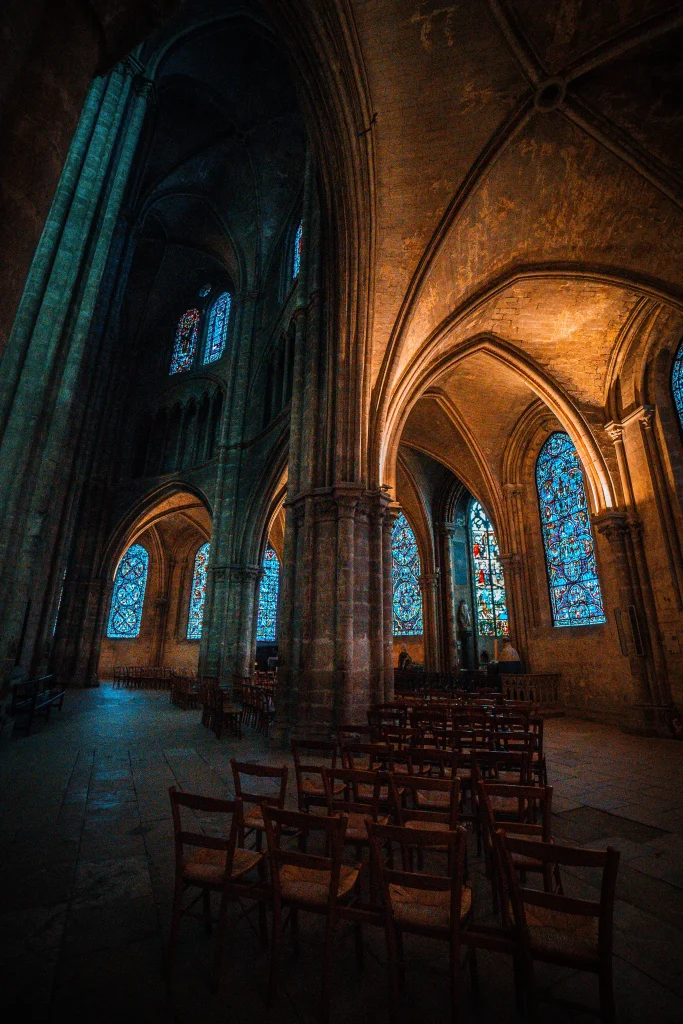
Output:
[167, 786, 269, 991]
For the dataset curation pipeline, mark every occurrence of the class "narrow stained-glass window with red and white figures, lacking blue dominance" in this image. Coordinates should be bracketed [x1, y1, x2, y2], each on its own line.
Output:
[470, 502, 510, 637]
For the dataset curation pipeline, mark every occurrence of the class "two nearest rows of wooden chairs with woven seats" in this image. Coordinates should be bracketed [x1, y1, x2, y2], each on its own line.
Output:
[169, 763, 618, 1022]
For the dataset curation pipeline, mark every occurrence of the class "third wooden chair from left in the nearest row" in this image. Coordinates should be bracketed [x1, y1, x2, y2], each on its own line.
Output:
[368, 822, 476, 1022]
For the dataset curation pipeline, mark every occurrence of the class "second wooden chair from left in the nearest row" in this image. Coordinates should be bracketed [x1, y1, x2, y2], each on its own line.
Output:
[263, 804, 362, 1024]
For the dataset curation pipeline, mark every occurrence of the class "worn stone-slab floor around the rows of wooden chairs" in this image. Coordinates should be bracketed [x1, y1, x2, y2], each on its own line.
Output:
[0, 685, 683, 1024]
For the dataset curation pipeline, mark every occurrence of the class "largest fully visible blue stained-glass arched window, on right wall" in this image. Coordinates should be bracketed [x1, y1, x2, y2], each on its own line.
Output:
[536, 431, 606, 626]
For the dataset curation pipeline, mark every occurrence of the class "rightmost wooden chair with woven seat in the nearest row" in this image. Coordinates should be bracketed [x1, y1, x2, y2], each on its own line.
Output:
[496, 828, 620, 1024]
